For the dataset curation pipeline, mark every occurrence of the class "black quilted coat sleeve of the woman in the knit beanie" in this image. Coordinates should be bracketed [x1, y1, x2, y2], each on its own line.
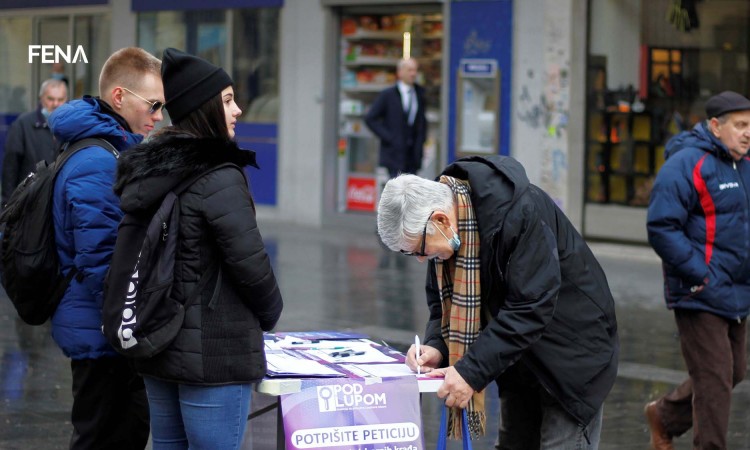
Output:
[203, 168, 283, 331]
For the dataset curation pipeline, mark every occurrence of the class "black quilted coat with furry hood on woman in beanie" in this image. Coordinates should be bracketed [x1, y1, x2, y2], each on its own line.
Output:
[115, 132, 283, 385]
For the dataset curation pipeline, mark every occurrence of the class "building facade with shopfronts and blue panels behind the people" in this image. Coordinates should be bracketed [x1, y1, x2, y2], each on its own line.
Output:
[8, 0, 750, 243]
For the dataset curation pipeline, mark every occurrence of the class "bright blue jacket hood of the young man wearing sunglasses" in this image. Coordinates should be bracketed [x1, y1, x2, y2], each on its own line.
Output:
[49, 96, 143, 151]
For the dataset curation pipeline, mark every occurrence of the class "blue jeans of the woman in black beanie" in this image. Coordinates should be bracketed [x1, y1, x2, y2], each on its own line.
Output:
[143, 376, 252, 450]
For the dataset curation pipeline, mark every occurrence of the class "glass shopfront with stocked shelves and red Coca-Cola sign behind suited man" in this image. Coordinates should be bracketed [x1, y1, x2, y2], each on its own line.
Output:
[337, 6, 444, 212]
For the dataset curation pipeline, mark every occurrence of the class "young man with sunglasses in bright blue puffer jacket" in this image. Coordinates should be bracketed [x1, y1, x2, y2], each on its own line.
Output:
[49, 47, 164, 450]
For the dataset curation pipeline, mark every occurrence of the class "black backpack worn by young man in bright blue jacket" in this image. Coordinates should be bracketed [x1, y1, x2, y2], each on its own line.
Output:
[0, 138, 119, 325]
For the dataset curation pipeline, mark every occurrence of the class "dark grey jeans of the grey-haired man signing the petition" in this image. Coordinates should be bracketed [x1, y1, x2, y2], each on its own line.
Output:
[495, 369, 604, 450]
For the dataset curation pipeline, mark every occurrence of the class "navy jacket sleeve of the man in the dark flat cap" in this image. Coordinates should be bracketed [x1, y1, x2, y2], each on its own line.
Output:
[646, 155, 709, 286]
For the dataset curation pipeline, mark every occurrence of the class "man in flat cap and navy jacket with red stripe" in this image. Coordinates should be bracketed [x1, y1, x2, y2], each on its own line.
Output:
[645, 91, 750, 449]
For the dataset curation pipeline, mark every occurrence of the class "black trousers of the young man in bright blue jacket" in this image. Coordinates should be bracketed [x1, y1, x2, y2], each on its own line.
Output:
[70, 357, 150, 450]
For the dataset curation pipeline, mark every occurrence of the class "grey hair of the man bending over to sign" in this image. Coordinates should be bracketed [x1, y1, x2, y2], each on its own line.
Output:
[378, 174, 454, 251]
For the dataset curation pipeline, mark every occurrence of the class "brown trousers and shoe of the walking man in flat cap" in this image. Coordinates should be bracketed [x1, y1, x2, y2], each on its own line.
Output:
[657, 309, 747, 449]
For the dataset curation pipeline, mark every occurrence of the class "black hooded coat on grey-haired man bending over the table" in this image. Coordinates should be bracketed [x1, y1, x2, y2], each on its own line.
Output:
[425, 156, 619, 424]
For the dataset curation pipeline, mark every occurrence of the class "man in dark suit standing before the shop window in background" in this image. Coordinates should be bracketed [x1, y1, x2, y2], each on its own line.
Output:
[365, 59, 427, 178]
